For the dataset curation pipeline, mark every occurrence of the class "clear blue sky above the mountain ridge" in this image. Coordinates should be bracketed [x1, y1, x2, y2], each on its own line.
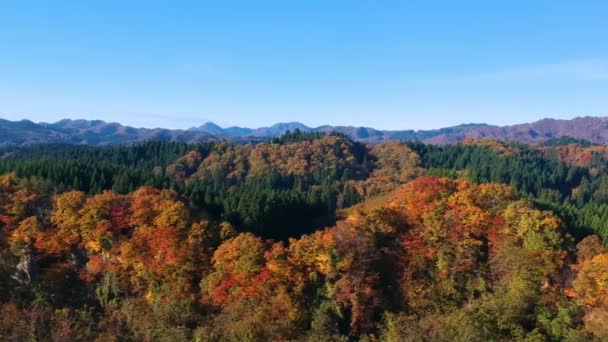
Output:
[0, 0, 608, 129]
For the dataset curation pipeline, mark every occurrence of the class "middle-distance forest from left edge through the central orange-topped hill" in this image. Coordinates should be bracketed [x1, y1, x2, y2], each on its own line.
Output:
[0, 135, 416, 240]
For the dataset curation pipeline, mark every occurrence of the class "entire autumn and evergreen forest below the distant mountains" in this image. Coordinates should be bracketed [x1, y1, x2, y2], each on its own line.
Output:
[0, 131, 608, 341]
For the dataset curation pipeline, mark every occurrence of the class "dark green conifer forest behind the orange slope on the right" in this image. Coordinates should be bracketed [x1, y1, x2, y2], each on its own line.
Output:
[407, 142, 608, 241]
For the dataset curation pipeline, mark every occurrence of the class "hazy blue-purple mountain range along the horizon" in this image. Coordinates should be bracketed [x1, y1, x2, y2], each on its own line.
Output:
[0, 116, 608, 146]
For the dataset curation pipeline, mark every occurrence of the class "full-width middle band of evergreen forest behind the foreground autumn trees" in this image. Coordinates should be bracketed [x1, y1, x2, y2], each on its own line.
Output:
[0, 135, 608, 244]
